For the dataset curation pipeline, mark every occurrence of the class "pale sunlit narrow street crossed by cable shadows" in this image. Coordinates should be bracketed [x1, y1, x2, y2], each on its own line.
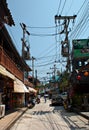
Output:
[10, 98, 89, 130]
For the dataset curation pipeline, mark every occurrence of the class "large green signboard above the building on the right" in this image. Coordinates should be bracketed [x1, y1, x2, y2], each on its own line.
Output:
[72, 39, 89, 58]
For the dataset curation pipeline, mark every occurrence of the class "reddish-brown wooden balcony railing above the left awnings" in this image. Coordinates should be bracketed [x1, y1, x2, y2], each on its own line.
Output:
[0, 47, 24, 81]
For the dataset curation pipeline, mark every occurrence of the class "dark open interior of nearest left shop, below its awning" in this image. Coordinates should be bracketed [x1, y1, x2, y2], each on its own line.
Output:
[0, 74, 13, 111]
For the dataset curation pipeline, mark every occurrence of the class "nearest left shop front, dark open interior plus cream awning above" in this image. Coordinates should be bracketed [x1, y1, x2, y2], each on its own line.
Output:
[0, 65, 14, 111]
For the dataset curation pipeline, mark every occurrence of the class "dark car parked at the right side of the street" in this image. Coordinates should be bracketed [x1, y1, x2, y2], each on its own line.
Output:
[51, 96, 63, 106]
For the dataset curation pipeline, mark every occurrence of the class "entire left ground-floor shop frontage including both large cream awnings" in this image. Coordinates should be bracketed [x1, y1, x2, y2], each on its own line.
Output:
[0, 65, 30, 111]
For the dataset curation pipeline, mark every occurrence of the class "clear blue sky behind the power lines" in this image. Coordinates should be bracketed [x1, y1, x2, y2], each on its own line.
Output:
[6, 0, 89, 80]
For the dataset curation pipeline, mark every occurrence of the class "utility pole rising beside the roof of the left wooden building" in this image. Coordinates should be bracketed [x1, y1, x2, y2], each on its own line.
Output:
[20, 23, 30, 59]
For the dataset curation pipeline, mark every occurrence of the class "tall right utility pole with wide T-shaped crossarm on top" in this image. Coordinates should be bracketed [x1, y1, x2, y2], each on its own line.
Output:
[55, 15, 76, 72]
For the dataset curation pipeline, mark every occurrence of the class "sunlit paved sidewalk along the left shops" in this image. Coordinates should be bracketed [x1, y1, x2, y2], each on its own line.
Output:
[0, 107, 28, 130]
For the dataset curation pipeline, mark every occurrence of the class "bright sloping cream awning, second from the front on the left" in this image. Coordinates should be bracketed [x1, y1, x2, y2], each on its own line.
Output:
[14, 79, 29, 93]
